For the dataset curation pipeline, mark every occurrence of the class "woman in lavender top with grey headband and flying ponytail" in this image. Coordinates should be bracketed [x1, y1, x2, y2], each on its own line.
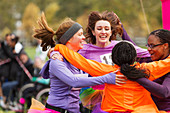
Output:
[30, 13, 123, 113]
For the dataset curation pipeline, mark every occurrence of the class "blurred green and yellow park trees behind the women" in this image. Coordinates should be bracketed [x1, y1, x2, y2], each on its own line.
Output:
[0, 0, 165, 113]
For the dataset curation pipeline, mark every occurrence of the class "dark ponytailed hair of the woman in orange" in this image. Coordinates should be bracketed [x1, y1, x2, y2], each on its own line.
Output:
[112, 41, 149, 80]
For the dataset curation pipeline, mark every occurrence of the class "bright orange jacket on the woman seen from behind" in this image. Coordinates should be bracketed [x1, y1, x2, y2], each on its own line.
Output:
[54, 44, 170, 113]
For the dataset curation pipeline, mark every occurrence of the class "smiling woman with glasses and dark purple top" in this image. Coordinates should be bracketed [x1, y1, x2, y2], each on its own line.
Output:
[137, 29, 170, 113]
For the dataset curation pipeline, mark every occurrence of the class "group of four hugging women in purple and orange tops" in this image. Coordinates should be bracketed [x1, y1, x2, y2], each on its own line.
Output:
[28, 11, 170, 113]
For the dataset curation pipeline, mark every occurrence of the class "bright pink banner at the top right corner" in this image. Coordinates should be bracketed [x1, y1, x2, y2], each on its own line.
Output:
[161, 0, 170, 30]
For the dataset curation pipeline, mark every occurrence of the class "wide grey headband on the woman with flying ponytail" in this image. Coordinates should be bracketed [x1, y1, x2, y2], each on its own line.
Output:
[59, 23, 82, 45]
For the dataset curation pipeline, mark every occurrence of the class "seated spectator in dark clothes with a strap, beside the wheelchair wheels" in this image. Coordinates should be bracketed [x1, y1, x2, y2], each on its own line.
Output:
[2, 34, 33, 109]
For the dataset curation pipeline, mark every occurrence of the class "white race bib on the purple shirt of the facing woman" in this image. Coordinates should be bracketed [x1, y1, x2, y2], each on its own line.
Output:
[100, 53, 114, 65]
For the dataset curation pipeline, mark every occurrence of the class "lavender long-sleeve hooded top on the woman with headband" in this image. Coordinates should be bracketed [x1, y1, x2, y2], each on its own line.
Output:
[40, 59, 115, 113]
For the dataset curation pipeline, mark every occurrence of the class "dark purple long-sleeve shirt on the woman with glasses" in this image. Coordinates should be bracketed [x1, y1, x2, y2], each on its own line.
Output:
[137, 73, 170, 111]
